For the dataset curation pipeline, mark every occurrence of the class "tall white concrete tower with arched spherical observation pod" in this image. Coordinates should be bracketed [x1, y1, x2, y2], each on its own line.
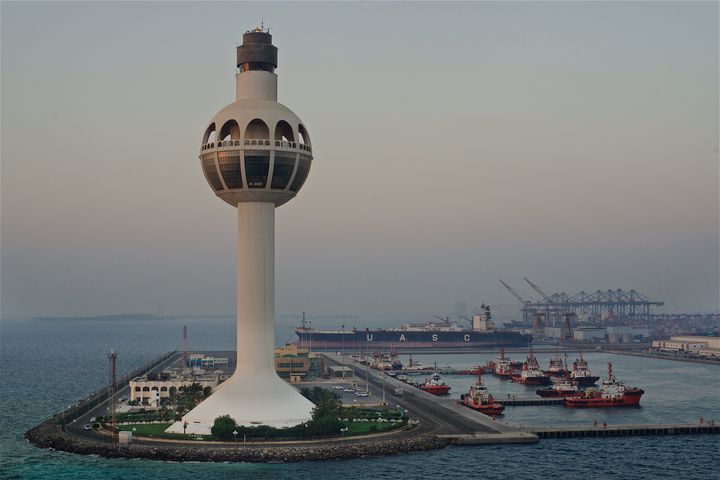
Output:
[168, 28, 314, 434]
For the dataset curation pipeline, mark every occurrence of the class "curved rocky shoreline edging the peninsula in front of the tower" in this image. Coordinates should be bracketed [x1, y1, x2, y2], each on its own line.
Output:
[25, 418, 450, 463]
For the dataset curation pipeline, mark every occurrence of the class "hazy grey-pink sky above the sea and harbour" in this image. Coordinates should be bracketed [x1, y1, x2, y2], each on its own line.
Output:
[1, 2, 720, 317]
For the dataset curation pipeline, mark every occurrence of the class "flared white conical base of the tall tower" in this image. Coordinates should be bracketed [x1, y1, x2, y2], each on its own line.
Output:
[170, 372, 315, 435]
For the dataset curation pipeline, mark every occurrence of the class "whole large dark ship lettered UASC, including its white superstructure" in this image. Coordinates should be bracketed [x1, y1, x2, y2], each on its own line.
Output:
[295, 305, 532, 351]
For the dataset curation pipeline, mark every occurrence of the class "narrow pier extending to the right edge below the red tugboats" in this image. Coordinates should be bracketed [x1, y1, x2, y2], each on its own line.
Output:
[526, 423, 720, 438]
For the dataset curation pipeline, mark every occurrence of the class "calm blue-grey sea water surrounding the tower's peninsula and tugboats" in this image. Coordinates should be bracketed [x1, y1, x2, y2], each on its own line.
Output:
[0, 318, 720, 480]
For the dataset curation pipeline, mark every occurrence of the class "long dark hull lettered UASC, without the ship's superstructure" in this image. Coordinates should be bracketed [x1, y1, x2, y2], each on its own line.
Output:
[295, 328, 532, 351]
